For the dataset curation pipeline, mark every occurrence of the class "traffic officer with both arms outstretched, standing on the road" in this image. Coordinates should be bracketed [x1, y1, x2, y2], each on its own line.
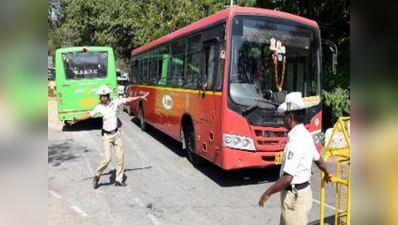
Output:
[69, 85, 149, 189]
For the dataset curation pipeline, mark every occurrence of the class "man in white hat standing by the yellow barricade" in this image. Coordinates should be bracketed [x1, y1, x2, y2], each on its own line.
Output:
[258, 92, 333, 225]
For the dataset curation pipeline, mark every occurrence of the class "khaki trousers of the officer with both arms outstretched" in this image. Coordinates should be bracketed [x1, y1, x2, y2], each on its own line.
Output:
[95, 130, 124, 182]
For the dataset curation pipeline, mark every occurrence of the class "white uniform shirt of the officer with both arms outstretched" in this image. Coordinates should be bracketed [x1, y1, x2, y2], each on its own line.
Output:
[90, 98, 126, 131]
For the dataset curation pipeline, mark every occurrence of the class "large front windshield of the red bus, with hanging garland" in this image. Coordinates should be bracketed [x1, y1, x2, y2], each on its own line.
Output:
[229, 16, 321, 109]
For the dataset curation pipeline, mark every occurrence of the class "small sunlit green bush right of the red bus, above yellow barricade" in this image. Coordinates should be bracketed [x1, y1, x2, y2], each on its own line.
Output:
[323, 87, 350, 124]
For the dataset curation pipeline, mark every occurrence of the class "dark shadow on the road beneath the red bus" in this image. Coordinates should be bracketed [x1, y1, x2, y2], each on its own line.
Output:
[131, 117, 280, 187]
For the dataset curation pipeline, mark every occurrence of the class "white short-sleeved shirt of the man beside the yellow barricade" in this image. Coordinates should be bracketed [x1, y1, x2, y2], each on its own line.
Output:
[280, 124, 320, 184]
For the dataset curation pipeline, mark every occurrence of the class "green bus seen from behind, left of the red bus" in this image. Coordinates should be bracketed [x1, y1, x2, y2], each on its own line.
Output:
[55, 47, 118, 122]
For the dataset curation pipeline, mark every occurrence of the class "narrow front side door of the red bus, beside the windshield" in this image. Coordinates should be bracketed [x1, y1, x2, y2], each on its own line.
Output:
[196, 26, 223, 164]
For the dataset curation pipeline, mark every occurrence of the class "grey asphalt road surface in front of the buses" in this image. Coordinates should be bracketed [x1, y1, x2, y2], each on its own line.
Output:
[48, 110, 334, 225]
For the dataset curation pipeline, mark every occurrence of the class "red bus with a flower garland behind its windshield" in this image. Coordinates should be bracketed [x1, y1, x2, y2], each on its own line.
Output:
[130, 7, 322, 170]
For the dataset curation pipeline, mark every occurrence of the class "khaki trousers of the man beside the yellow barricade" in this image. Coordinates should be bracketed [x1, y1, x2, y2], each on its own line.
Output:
[280, 185, 312, 225]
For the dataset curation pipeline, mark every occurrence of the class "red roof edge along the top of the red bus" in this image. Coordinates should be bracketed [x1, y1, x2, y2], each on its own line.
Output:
[132, 6, 319, 54]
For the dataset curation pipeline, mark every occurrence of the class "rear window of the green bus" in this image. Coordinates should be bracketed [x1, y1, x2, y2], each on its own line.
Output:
[62, 52, 108, 80]
